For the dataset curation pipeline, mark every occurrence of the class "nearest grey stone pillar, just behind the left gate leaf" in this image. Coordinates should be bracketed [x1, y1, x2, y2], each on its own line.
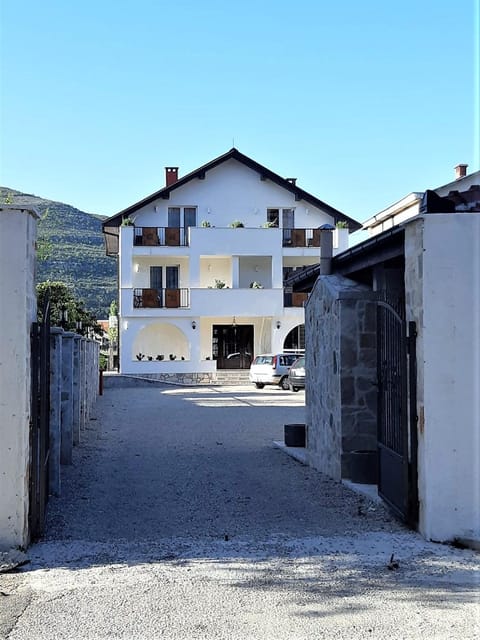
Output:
[49, 327, 63, 496]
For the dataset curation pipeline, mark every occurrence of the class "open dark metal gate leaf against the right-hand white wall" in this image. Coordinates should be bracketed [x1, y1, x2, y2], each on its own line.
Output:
[377, 301, 418, 526]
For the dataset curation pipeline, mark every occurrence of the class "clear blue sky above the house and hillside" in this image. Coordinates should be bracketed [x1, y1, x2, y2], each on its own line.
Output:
[0, 0, 480, 242]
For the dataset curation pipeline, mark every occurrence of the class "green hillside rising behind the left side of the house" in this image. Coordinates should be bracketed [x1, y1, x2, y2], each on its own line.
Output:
[0, 187, 117, 319]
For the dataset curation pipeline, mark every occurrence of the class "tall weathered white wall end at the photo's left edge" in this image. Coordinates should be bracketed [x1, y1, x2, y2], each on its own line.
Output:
[0, 206, 38, 549]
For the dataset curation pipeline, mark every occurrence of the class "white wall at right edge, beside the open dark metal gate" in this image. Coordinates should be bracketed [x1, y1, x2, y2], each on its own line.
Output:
[405, 213, 480, 541]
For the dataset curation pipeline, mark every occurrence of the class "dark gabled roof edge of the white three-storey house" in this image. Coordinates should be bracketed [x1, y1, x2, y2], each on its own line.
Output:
[103, 147, 362, 233]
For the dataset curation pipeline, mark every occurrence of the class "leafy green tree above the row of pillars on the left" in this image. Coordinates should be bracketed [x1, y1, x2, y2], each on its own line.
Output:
[37, 280, 100, 335]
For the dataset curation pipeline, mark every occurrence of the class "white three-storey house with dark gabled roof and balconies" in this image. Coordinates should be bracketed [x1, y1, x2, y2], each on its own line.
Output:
[103, 148, 360, 382]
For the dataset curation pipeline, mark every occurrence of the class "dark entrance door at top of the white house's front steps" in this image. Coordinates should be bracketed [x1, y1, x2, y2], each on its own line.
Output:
[212, 324, 253, 369]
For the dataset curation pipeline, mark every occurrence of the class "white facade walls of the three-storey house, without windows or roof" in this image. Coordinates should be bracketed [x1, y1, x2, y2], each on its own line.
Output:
[115, 160, 338, 373]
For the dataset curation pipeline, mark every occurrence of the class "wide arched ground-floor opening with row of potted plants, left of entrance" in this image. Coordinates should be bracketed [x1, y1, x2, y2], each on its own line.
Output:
[132, 322, 190, 361]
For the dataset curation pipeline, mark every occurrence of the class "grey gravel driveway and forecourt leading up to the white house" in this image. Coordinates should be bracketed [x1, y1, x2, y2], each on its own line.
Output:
[0, 386, 480, 640]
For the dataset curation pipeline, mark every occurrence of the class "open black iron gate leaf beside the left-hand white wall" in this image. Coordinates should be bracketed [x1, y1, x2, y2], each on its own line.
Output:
[29, 301, 50, 540]
